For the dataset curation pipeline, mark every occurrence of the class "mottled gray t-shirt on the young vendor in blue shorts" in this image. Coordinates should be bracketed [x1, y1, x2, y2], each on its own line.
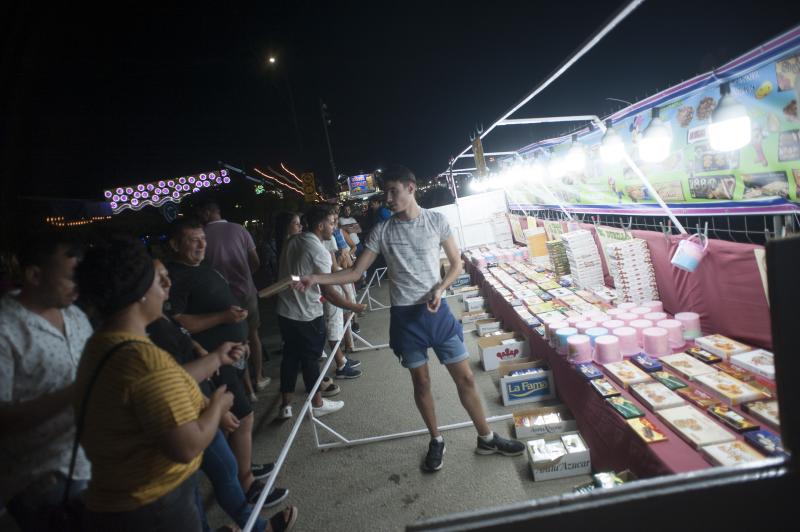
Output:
[365, 209, 451, 306]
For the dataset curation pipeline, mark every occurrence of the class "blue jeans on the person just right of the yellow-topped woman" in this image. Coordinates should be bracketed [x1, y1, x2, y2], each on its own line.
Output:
[196, 430, 267, 532]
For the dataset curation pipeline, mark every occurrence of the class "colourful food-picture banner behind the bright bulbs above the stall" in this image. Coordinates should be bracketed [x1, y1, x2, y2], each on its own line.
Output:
[508, 28, 800, 215]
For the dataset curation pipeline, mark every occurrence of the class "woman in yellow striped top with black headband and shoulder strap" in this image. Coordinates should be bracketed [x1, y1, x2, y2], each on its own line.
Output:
[75, 239, 233, 532]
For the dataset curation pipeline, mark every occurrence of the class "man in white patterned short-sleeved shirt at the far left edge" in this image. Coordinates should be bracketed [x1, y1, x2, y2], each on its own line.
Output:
[0, 234, 92, 531]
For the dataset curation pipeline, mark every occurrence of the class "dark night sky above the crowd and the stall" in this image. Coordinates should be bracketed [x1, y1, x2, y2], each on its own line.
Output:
[3, 0, 800, 199]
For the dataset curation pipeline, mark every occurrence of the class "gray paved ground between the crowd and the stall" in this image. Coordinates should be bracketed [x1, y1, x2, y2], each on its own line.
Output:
[203, 285, 588, 531]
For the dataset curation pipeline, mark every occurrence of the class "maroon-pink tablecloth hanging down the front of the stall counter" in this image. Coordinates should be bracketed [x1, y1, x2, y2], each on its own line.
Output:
[465, 262, 710, 478]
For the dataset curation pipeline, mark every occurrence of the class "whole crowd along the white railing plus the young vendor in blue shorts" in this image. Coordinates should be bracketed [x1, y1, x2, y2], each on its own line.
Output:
[0, 167, 523, 532]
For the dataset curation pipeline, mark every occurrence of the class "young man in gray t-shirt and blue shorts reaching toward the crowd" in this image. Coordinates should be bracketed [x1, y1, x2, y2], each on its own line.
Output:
[298, 166, 525, 471]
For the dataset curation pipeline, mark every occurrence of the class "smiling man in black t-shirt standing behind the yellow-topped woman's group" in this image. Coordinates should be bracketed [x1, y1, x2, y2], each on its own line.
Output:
[165, 218, 266, 493]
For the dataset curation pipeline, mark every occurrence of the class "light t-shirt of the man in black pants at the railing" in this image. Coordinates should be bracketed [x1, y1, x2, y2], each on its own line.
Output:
[277, 233, 332, 321]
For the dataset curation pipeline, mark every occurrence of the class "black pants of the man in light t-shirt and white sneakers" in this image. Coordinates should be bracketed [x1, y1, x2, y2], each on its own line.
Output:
[278, 316, 325, 393]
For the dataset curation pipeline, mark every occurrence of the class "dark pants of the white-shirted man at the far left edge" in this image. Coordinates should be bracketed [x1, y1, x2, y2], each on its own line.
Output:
[6, 473, 88, 532]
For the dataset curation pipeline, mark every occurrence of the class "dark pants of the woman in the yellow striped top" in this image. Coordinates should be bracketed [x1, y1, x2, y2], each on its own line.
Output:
[85, 474, 202, 532]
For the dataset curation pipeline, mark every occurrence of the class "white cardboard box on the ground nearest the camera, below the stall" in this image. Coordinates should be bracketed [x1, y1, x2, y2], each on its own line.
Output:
[527, 432, 592, 482]
